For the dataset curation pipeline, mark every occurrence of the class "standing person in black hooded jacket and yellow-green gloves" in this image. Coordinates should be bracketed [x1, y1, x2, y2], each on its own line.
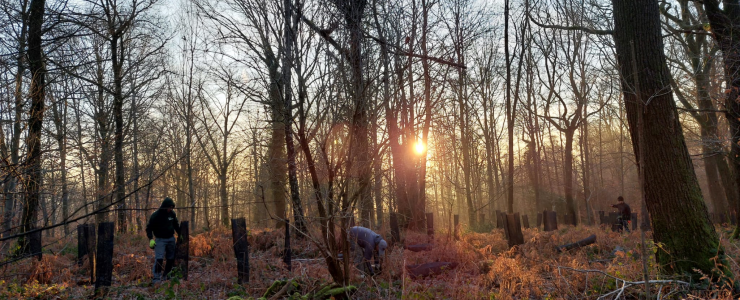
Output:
[146, 197, 180, 283]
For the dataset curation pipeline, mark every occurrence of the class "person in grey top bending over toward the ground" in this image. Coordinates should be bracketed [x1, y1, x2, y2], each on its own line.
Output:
[349, 226, 388, 275]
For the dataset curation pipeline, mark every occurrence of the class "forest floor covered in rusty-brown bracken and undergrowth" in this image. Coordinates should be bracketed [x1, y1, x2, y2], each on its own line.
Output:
[0, 226, 740, 299]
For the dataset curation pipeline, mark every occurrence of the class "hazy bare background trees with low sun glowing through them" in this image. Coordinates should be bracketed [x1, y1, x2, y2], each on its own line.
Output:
[0, 0, 740, 277]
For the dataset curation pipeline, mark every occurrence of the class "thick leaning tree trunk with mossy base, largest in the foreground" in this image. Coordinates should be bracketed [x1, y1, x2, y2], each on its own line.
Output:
[612, 0, 723, 279]
